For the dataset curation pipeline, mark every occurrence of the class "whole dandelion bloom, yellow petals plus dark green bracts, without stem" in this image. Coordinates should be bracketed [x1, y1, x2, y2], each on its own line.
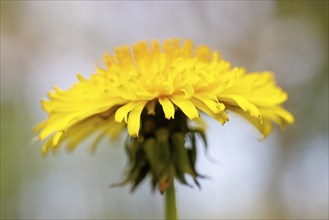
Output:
[35, 39, 294, 191]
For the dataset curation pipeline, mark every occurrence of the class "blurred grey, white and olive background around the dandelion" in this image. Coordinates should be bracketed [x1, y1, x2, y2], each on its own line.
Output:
[1, 1, 328, 219]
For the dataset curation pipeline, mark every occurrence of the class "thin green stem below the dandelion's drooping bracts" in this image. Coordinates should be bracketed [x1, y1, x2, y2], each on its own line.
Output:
[165, 181, 177, 220]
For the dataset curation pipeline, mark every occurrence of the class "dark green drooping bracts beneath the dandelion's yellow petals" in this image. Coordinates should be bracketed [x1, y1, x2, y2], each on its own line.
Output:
[112, 106, 207, 193]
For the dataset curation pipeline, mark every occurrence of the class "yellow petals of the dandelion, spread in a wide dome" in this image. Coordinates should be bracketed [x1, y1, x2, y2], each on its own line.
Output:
[35, 39, 294, 154]
